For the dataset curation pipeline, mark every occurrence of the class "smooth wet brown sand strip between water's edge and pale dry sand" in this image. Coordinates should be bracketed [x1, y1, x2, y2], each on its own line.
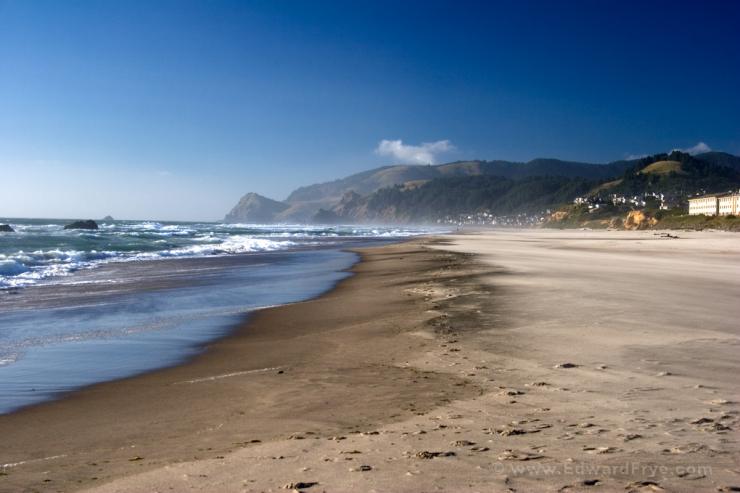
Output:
[0, 242, 482, 491]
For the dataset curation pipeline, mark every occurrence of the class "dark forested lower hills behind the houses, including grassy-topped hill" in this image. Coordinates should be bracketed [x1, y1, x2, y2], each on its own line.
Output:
[315, 152, 740, 222]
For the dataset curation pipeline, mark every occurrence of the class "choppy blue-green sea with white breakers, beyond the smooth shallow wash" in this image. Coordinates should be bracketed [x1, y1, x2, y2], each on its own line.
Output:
[0, 220, 440, 289]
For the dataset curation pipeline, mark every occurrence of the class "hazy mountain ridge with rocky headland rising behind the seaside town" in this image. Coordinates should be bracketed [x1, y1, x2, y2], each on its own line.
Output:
[224, 152, 740, 223]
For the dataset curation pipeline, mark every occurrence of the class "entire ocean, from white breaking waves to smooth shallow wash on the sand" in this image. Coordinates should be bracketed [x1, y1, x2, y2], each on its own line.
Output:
[0, 218, 434, 414]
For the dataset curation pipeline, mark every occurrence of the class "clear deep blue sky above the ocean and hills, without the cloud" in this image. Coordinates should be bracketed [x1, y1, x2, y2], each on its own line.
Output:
[0, 0, 740, 220]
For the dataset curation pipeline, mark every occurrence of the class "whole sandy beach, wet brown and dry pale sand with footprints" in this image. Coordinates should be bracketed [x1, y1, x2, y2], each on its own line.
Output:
[0, 230, 740, 492]
